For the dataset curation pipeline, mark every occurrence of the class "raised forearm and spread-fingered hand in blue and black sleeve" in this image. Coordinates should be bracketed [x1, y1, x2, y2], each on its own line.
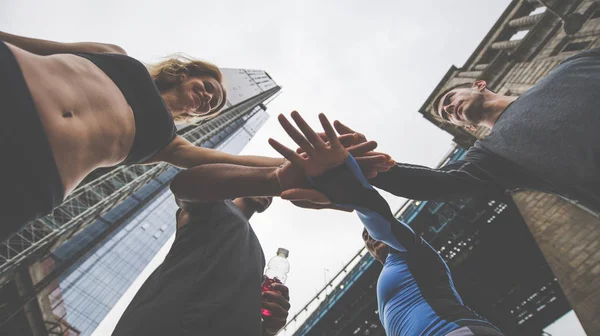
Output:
[270, 112, 417, 251]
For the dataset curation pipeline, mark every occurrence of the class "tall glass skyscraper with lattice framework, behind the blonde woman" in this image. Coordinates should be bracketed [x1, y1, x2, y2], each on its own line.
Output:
[0, 69, 281, 335]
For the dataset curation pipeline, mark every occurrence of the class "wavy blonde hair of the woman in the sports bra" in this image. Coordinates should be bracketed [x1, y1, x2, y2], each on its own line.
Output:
[146, 54, 227, 124]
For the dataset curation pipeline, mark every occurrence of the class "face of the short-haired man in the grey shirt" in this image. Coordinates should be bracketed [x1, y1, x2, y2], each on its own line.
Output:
[437, 82, 485, 126]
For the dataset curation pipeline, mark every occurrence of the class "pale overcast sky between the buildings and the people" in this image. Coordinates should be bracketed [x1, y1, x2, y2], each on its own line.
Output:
[0, 0, 584, 335]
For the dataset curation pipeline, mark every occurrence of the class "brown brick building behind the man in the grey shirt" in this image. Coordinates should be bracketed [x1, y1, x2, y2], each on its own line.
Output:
[419, 0, 600, 335]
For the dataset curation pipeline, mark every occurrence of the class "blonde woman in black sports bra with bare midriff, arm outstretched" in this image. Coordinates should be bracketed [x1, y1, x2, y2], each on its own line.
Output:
[0, 32, 292, 240]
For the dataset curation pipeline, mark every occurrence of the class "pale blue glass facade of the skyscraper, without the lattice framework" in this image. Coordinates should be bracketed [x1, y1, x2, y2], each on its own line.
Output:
[38, 69, 278, 335]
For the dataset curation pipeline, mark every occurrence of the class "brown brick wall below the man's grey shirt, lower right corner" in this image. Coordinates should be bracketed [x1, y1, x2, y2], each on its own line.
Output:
[513, 192, 600, 335]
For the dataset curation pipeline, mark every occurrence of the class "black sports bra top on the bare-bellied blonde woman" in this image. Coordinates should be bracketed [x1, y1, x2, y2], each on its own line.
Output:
[76, 53, 177, 164]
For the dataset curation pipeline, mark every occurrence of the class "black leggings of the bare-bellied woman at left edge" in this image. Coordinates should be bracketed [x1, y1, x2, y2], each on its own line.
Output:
[0, 41, 64, 241]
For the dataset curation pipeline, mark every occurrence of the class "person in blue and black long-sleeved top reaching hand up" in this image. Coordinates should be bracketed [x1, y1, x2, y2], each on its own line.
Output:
[269, 112, 503, 336]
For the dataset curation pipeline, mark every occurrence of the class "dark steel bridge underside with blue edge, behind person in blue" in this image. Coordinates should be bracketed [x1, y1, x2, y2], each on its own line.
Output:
[281, 147, 571, 336]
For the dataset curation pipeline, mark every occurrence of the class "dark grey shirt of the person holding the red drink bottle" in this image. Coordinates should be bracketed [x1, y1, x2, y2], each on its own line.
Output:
[113, 200, 265, 336]
